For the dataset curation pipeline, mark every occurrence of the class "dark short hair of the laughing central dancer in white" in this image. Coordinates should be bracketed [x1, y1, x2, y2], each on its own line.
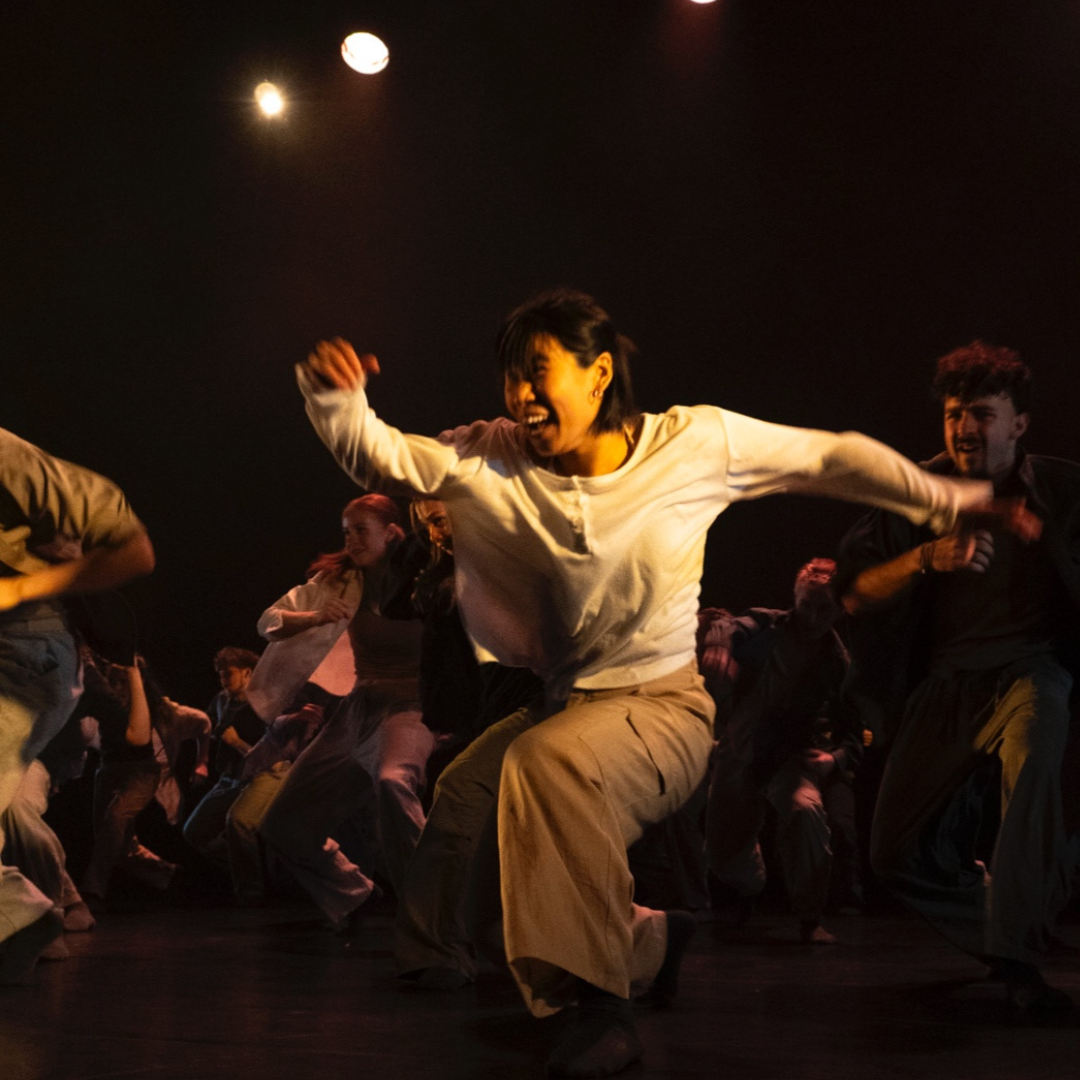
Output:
[496, 288, 639, 432]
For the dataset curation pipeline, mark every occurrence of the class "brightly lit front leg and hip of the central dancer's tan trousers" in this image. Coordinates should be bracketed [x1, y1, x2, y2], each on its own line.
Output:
[498, 664, 713, 1016]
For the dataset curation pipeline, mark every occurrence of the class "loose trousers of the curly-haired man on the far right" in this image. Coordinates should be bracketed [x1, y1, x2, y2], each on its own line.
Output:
[870, 657, 1075, 963]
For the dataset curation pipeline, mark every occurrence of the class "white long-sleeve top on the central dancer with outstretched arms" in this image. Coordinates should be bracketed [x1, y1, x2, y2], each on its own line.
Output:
[298, 372, 990, 698]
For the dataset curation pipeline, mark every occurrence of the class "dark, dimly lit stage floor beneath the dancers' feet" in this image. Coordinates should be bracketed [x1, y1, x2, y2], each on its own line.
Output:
[0, 907, 1080, 1080]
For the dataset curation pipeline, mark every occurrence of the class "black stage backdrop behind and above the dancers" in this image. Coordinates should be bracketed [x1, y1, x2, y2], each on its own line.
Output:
[0, 0, 1080, 704]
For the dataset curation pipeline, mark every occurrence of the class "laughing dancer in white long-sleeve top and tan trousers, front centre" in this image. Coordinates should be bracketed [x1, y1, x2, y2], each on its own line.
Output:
[298, 291, 1028, 1076]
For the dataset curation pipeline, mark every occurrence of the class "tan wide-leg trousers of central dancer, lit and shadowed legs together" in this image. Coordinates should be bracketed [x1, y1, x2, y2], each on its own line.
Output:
[395, 666, 713, 1015]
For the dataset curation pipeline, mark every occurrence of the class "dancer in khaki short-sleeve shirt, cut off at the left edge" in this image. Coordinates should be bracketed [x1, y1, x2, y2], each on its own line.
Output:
[0, 430, 153, 984]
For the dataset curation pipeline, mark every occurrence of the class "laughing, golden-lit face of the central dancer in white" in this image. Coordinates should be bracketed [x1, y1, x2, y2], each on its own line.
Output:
[504, 334, 611, 458]
